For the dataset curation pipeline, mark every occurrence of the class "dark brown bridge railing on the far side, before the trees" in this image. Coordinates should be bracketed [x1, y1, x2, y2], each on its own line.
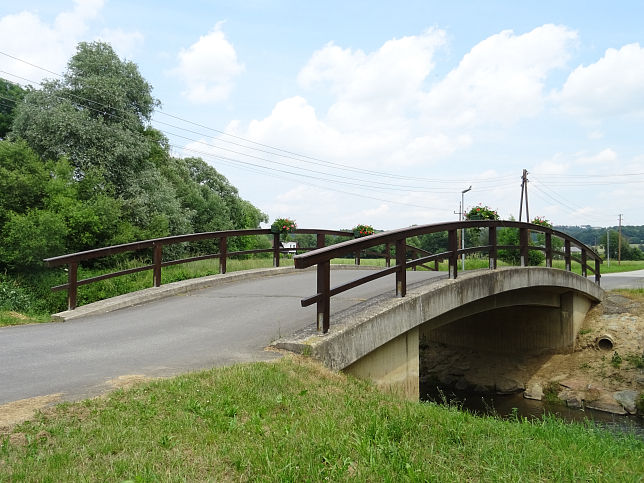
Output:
[44, 228, 360, 310]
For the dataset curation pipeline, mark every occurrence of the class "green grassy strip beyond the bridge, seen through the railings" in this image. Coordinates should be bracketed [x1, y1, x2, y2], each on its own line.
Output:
[0, 258, 644, 327]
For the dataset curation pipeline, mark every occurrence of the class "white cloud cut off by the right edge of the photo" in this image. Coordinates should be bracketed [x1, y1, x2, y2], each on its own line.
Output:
[553, 43, 644, 118]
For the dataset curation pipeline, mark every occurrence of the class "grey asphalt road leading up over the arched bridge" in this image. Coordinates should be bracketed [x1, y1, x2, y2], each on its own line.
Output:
[0, 270, 446, 404]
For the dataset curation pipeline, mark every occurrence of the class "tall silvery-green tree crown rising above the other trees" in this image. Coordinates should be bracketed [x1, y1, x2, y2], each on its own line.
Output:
[13, 42, 158, 194]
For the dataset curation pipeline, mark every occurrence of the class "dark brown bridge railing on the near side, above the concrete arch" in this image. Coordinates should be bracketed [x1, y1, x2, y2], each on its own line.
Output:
[294, 220, 602, 333]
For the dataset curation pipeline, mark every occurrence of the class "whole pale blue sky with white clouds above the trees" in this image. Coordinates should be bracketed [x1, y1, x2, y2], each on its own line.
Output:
[0, 0, 644, 229]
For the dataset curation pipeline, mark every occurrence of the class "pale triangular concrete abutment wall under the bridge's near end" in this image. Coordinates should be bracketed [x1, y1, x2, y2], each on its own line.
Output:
[344, 327, 420, 401]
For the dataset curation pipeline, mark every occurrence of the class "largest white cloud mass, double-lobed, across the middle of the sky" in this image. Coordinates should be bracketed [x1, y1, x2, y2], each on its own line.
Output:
[223, 25, 577, 176]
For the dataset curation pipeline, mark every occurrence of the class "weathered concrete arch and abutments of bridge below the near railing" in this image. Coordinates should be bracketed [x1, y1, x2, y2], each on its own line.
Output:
[274, 267, 604, 398]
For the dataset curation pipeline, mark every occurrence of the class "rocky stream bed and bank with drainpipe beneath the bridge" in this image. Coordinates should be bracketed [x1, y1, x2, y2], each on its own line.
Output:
[420, 292, 644, 416]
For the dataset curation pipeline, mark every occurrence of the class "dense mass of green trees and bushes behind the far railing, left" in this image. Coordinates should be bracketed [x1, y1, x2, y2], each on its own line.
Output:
[0, 42, 269, 310]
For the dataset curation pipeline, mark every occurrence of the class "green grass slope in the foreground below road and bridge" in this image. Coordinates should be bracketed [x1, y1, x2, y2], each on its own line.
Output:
[0, 358, 644, 481]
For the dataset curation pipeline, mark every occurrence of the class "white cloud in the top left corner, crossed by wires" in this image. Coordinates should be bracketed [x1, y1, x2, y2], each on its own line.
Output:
[0, 0, 104, 84]
